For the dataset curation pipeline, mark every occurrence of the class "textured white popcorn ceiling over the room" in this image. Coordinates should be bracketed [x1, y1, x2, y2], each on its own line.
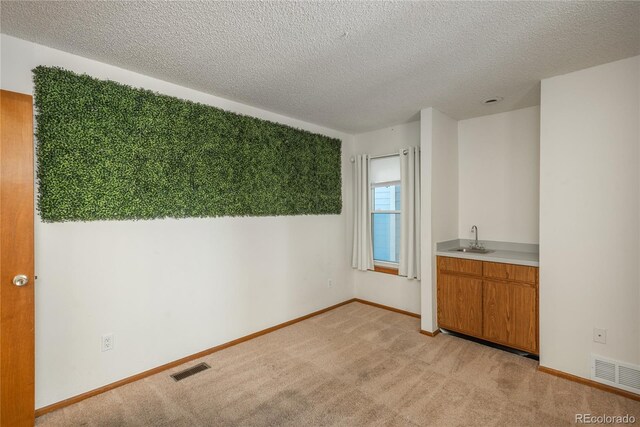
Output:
[1, 0, 640, 132]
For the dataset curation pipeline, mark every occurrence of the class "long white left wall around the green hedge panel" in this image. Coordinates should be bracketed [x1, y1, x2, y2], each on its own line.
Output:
[0, 35, 353, 407]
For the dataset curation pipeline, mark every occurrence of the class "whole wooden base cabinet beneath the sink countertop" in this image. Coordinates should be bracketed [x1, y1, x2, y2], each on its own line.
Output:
[437, 257, 539, 354]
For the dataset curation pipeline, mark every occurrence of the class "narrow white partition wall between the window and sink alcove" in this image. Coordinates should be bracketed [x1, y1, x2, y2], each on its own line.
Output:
[420, 108, 458, 332]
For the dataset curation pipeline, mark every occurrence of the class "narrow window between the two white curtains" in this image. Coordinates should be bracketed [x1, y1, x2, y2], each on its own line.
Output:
[371, 156, 401, 268]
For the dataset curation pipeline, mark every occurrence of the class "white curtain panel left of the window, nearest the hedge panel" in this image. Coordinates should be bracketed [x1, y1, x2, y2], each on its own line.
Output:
[351, 154, 373, 271]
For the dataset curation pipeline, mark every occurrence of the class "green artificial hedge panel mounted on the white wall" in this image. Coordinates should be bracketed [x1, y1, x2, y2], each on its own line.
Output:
[33, 66, 342, 222]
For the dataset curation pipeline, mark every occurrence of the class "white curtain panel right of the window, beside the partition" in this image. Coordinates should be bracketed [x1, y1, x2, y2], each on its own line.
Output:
[398, 147, 420, 280]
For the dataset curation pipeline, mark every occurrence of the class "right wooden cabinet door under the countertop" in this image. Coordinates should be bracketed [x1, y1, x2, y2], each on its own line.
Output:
[482, 280, 538, 354]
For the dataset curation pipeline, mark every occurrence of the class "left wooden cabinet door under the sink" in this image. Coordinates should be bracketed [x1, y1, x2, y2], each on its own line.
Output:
[438, 273, 482, 337]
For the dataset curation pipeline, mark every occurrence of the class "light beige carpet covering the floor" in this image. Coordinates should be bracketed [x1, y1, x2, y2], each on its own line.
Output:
[37, 302, 640, 426]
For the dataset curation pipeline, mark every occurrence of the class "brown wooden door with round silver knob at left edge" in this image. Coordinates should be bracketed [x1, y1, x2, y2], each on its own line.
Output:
[0, 90, 35, 427]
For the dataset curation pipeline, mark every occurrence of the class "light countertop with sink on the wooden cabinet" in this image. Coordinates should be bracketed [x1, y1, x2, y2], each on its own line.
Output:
[436, 239, 540, 267]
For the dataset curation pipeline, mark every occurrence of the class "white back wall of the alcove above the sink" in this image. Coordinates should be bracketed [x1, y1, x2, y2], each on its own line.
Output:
[458, 106, 540, 243]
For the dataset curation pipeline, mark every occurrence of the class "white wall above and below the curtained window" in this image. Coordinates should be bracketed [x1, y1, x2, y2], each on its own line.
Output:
[345, 121, 420, 313]
